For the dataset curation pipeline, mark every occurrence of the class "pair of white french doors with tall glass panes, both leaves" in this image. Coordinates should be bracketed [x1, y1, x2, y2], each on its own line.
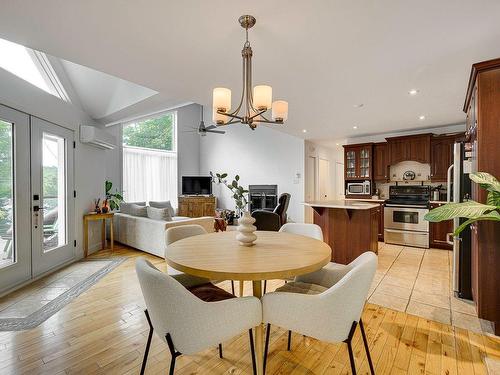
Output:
[0, 105, 75, 293]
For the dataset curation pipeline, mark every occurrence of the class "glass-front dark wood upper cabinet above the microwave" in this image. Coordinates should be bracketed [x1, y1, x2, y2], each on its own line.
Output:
[344, 143, 373, 180]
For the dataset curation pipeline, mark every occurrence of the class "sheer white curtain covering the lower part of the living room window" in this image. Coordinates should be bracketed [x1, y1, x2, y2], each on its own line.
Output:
[123, 146, 177, 207]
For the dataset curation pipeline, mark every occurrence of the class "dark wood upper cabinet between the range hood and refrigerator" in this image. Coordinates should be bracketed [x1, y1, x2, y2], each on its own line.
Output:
[431, 133, 464, 182]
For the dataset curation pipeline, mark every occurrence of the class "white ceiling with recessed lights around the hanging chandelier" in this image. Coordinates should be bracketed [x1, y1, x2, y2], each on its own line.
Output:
[0, 0, 500, 140]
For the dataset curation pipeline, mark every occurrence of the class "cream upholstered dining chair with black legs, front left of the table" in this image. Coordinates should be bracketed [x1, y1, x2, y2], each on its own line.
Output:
[135, 258, 262, 375]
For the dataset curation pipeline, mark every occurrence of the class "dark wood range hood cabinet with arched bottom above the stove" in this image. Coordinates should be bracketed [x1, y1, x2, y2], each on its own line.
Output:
[386, 134, 431, 165]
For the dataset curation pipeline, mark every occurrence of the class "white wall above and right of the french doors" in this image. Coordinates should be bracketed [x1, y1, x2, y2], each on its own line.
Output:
[0, 69, 107, 257]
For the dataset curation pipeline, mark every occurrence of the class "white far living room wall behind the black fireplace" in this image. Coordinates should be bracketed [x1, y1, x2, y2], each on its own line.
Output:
[200, 124, 304, 222]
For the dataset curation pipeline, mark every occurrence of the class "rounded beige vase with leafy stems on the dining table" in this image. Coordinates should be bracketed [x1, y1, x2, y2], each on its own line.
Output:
[210, 172, 257, 246]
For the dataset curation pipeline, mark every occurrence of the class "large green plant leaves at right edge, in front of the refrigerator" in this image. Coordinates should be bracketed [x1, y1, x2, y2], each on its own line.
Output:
[424, 172, 500, 236]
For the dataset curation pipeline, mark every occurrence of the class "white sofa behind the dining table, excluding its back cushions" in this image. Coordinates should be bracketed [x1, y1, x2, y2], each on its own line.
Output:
[114, 212, 214, 258]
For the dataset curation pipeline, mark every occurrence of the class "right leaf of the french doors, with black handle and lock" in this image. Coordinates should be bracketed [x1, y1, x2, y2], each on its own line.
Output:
[31, 117, 75, 276]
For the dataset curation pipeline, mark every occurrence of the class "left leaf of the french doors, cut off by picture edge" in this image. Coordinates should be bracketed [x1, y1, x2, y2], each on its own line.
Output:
[0, 105, 31, 293]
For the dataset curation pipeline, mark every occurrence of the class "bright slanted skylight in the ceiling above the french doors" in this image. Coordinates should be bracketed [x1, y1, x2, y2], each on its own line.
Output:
[0, 38, 69, 101]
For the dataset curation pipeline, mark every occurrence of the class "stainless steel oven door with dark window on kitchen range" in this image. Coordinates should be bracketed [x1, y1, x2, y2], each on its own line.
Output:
[384, 206, 429, 232]
